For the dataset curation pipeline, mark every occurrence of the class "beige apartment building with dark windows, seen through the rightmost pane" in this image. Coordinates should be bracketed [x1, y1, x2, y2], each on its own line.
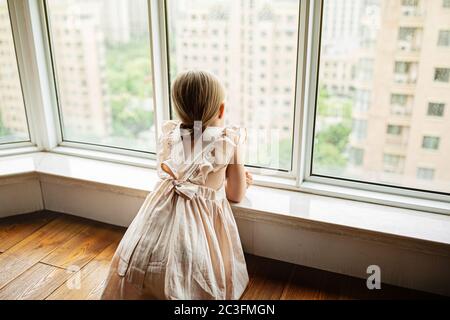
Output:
[349, 0, 450, 190]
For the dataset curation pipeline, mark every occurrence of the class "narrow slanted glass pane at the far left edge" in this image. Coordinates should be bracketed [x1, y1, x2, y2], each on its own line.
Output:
[0, 0, 30, 144]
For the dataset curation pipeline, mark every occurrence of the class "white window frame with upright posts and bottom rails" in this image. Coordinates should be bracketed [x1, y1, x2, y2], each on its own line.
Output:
[0, 0, 450, 214]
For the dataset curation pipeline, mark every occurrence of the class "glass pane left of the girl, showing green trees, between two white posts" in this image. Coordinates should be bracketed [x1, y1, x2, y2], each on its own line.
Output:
[47, 0, 155, 152]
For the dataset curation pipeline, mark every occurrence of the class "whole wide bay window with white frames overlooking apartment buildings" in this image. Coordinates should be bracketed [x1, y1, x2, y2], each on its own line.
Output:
[0, 0, 450, 212]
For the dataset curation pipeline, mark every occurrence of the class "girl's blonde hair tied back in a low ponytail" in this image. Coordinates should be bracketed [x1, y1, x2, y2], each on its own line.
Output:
[172, 71, 225, 129]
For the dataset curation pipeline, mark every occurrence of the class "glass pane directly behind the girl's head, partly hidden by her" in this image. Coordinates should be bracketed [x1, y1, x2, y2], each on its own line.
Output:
[168, 0, 299, 170]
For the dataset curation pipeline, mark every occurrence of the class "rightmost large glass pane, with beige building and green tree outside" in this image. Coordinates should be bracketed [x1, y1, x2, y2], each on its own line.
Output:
[312, 0, 450, 193]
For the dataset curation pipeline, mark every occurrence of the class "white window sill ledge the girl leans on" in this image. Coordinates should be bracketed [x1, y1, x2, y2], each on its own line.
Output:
[0, 152, 450, 255]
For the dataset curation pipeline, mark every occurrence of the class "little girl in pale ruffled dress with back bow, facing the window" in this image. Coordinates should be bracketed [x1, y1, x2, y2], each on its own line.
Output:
[102, 71, 252, 299]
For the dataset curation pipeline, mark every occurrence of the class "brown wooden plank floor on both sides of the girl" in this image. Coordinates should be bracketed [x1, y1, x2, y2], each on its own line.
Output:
[0, 212, 436, 300]
